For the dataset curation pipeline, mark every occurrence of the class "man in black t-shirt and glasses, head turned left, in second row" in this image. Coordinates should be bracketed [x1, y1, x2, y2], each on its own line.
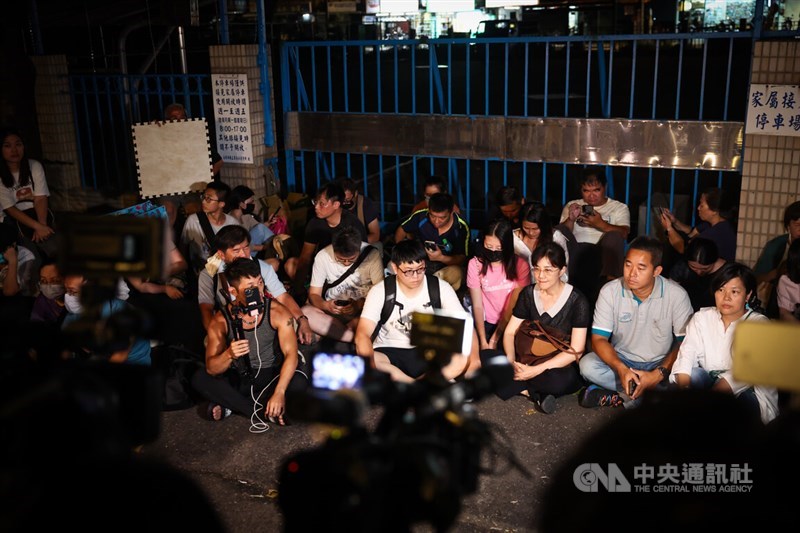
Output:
[286, 183, 367, 294]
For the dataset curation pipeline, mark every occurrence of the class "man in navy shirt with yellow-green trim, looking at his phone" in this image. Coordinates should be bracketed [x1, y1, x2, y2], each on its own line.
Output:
[394, 193, 469, 290]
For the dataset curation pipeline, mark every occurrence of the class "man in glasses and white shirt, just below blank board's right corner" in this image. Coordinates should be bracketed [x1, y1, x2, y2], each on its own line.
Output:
[181, 181, 239, 275]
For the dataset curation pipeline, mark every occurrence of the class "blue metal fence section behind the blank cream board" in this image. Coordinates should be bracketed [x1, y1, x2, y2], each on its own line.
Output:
[69, 74, 213, 192]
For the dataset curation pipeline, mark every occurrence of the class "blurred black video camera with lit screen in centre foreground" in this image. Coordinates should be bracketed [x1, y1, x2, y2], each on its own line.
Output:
[278, 313, 527, 531]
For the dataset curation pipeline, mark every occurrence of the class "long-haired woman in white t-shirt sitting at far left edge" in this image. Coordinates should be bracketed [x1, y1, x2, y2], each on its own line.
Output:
[0, 131, 54, 250]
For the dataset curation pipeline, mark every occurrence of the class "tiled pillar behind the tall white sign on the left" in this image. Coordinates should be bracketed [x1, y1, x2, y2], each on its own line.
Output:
[209, 44, 278, 197]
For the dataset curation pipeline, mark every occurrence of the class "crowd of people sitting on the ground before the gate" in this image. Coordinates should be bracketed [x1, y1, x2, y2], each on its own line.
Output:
[0, 169, 800, 425]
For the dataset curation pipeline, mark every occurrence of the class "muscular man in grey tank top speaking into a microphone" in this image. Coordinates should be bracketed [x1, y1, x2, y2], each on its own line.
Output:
[192, 257, 306, 425]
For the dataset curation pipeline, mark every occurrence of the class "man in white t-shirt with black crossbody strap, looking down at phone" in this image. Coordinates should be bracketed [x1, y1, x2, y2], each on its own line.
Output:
[303, 227, 383, 343]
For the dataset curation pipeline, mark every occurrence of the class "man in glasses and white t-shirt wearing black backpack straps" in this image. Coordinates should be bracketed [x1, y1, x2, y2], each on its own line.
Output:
[356, 240, 478, 382]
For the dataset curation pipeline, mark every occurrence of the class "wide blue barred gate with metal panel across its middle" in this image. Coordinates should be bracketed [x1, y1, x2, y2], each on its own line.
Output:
[281, 32, 753, 231]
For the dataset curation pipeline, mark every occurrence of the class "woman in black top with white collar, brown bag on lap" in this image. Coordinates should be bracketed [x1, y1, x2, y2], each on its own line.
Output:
[498, 242, 592, 414]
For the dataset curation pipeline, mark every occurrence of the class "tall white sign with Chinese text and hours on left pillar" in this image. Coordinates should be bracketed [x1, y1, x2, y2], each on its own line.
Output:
[211, 74, 253, 164]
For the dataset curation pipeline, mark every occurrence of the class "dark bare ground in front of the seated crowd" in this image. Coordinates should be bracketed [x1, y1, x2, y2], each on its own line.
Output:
[142, 388, 621, 532]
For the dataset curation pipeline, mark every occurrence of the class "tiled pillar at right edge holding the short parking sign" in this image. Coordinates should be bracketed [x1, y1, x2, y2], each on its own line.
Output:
[736, 41, 800, 266]
